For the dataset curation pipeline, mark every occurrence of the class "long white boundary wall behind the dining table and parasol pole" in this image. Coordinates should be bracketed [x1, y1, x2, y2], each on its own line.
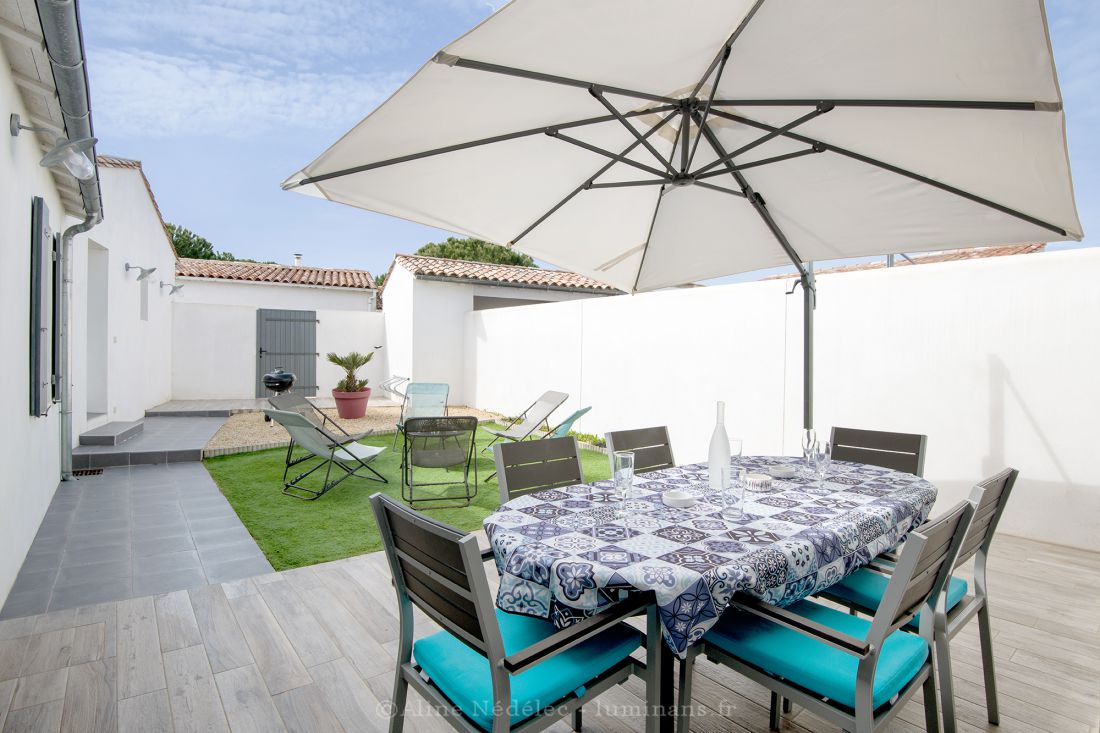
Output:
[463, 249, 1100, 550]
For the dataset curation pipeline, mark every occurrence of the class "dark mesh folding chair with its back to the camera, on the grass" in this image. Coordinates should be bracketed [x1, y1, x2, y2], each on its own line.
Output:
[402, 415, 477, 506]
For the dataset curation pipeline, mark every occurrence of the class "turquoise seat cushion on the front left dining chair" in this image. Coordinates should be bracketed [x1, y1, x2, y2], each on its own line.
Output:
[413, 610, 641, 731]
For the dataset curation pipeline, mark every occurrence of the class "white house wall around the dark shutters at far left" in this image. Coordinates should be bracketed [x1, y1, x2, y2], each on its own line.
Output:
[0, 61, 73, 603]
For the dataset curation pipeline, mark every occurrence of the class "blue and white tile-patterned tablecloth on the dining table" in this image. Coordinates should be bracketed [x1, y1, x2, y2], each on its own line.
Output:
[485, 457, 936, 655]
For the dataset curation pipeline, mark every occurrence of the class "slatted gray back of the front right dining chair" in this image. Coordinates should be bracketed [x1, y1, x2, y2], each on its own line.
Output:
[867, 488, 981, 648]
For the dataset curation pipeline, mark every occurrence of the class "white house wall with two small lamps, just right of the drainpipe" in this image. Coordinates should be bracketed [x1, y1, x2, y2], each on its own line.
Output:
[72, 165, 178, 433]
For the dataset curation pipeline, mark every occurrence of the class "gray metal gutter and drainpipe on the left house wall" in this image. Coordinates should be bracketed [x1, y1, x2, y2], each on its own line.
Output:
[36, 0, 103, 481]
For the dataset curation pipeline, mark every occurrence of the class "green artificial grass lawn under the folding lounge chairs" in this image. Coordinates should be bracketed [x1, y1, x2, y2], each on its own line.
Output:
[204, 422, 611, 570]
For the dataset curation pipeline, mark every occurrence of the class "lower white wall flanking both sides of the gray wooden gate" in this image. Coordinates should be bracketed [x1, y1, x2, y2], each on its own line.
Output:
[172, 301, 386, 400]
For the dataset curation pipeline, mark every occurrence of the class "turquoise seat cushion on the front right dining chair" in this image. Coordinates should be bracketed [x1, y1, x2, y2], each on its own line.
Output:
[703, 601, 928, 709]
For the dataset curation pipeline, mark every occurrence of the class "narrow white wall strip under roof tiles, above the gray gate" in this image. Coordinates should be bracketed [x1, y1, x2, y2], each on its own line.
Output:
[175, 277, 374, 310]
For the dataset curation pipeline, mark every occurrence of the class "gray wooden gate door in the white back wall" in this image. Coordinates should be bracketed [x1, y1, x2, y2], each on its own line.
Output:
[256, 308, 318, 397]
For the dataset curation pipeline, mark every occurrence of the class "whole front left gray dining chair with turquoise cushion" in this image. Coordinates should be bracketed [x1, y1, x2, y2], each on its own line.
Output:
[371, 493, 662, 733]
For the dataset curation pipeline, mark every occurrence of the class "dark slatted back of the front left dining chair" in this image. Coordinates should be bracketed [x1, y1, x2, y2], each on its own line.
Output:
[371, 494, 503, 659]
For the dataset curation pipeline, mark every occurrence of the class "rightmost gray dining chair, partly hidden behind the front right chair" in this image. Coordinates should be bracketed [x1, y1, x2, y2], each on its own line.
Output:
[822, 468, 1020, 733]
